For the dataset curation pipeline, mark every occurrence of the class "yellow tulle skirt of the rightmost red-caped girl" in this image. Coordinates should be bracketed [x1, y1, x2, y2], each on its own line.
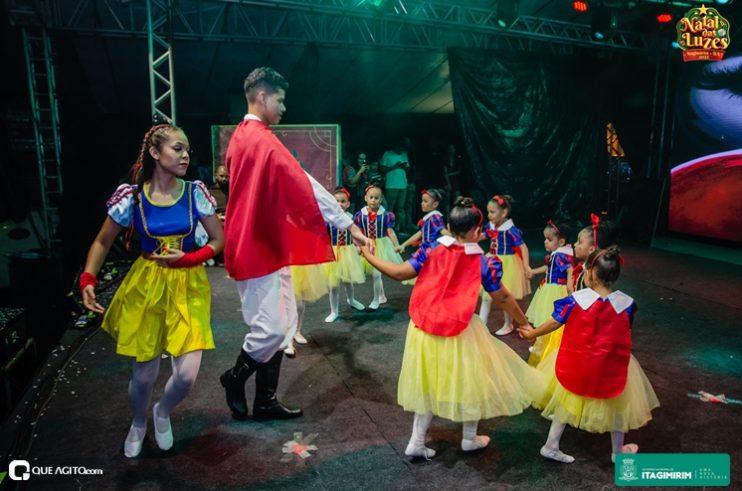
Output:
[534, 350, 660, 433]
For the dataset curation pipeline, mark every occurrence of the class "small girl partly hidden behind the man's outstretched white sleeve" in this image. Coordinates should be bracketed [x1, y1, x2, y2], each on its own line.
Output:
[323, 188, 366, 322]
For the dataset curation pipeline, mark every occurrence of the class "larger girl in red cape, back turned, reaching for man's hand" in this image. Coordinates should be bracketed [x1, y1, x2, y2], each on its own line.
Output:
[361, 197, 545, 459]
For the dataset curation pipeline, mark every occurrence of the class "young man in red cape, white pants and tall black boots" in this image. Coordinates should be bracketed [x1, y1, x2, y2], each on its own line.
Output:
[220, 67, 372, 421]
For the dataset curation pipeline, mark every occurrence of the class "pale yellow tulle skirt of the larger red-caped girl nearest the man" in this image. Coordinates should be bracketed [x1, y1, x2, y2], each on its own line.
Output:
[397, 315, 546, 421]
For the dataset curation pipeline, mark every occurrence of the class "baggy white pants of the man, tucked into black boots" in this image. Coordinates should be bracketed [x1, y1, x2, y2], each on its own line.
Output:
[237, 266, 297, 363]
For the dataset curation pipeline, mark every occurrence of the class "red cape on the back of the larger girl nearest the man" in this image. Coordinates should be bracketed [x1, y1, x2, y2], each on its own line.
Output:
[410, 245, 482, 336]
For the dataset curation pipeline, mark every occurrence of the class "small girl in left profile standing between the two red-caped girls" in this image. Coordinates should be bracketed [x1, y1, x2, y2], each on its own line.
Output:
[526, 220, 574, 366]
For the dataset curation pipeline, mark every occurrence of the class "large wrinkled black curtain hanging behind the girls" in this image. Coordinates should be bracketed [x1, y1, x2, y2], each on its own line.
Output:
[448, 48, 615, 226]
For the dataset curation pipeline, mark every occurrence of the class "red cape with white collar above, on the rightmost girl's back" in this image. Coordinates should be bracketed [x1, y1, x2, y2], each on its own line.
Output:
[556, 301, 631, 399]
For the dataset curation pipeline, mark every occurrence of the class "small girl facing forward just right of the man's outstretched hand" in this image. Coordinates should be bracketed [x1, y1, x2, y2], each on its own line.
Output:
[353, 184, 402, 310]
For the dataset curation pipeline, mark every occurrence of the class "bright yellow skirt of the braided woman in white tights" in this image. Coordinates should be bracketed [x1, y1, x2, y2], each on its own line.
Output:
[102, 257, 214, 362]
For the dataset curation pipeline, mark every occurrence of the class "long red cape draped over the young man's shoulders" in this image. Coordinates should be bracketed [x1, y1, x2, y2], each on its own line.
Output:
[224, 119, 335, 280]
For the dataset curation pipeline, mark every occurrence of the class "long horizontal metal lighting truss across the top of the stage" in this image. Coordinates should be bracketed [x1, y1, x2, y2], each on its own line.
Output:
[24, 0, 649, 51]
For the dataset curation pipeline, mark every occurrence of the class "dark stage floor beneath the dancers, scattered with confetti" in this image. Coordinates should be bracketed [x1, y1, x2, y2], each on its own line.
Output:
[2, 248, 742, 490]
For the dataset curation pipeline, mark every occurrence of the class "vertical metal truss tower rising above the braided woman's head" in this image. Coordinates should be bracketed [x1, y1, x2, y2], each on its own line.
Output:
[146, 0, 176, 124]
